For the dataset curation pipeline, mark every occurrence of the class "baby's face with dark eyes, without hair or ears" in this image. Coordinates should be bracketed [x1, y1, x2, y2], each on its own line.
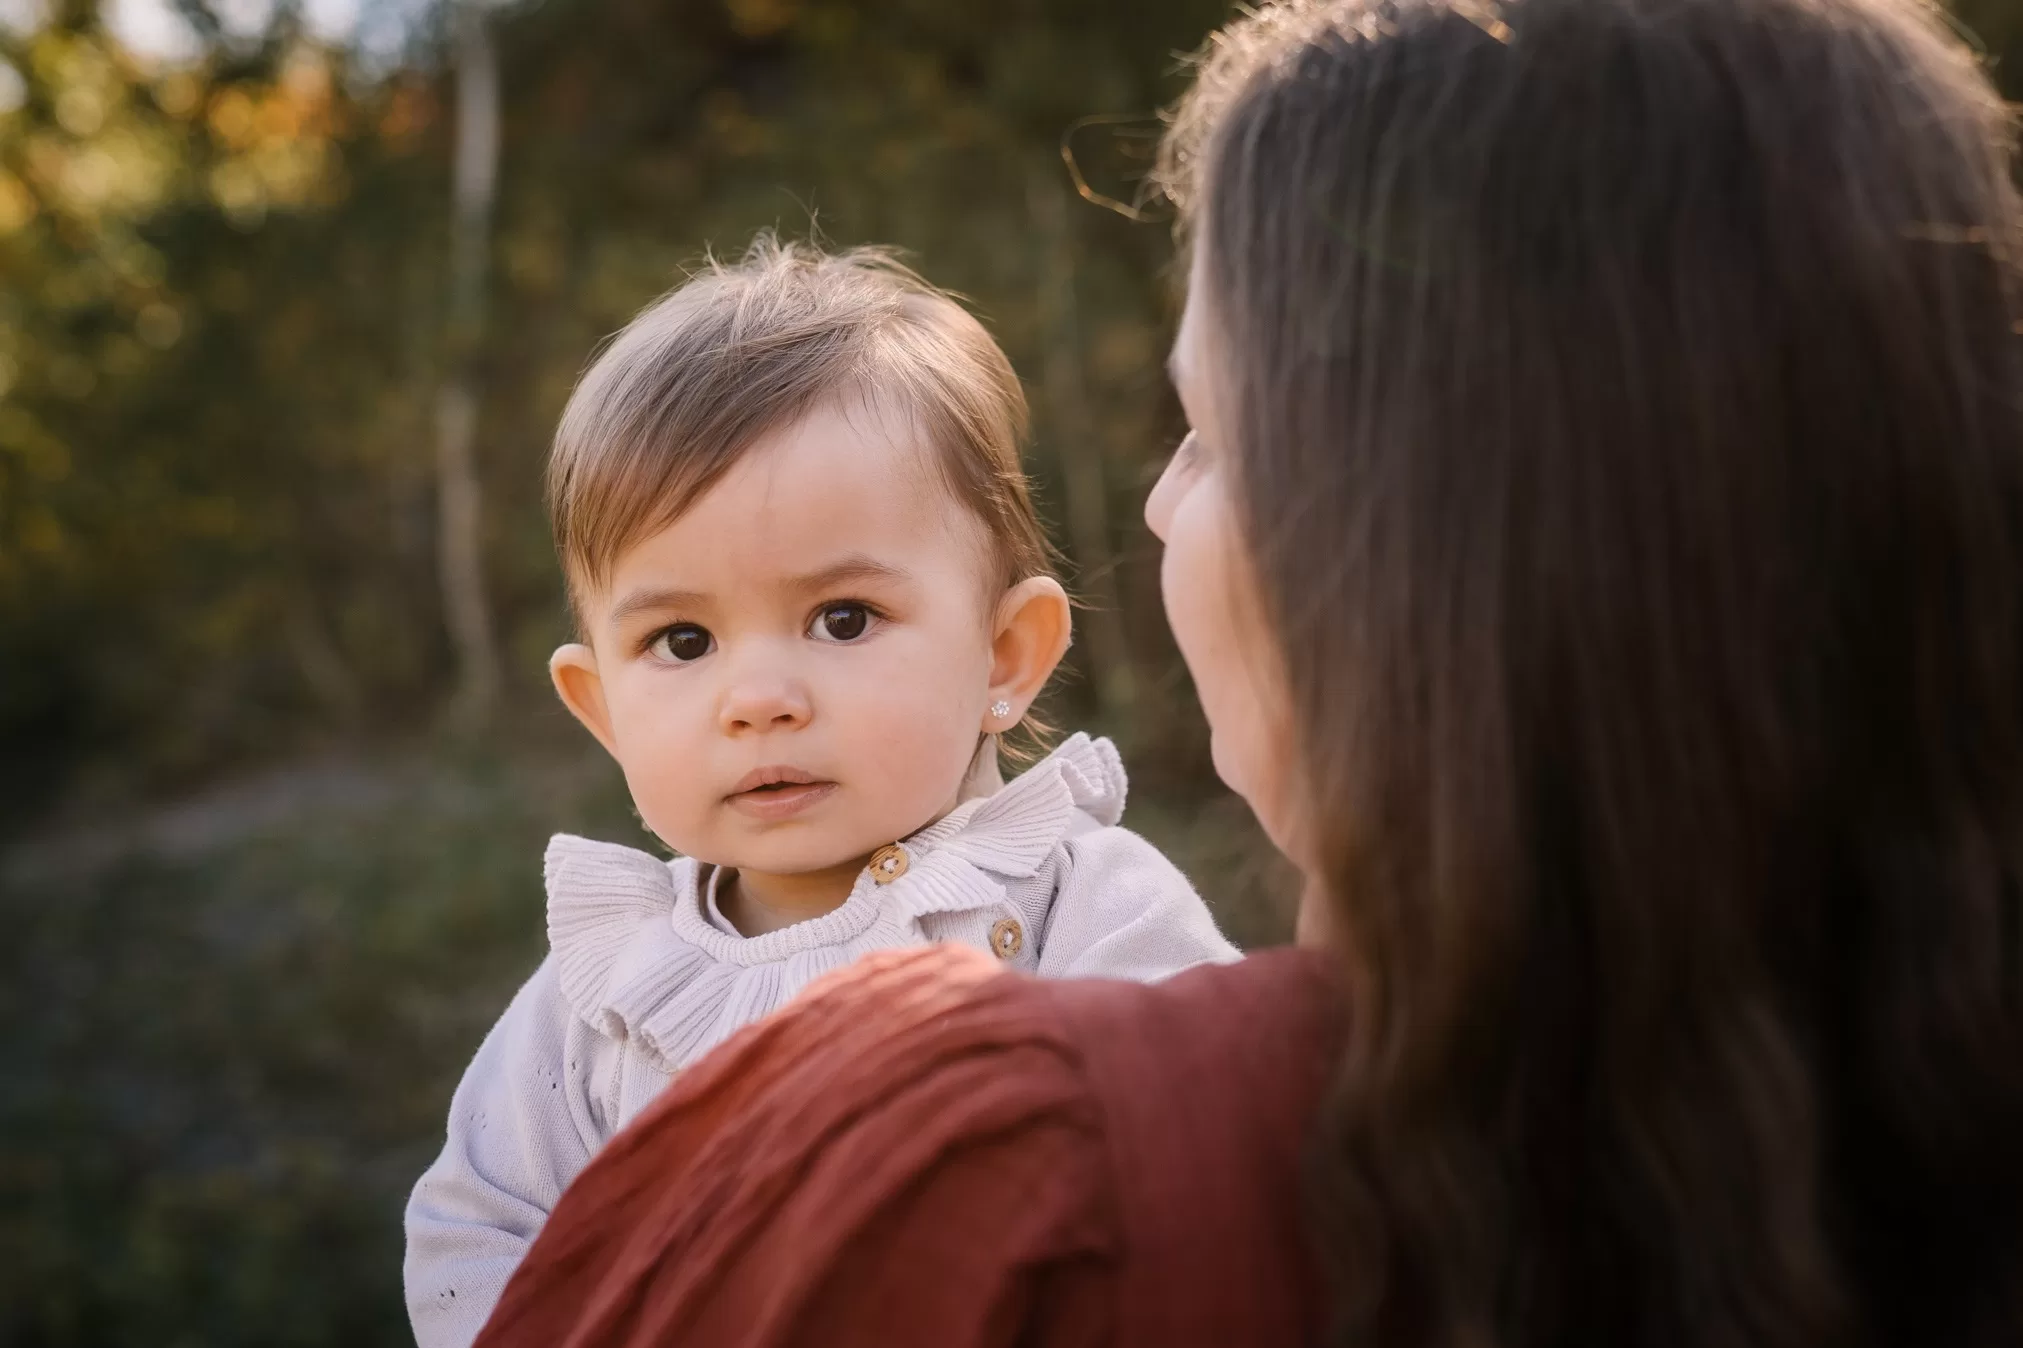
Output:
[562, 396, 993, 874]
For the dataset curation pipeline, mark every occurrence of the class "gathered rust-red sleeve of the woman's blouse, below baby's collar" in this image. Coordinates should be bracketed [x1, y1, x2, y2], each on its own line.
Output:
[479, 945, 1117, 1348]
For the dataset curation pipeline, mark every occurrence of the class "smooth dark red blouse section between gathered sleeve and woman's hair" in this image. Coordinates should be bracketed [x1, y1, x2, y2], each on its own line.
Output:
[1048, 949, 1341, 1346]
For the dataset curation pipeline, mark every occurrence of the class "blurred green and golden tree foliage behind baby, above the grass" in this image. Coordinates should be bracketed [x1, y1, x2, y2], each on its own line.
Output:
[0, 0, 1224, 820]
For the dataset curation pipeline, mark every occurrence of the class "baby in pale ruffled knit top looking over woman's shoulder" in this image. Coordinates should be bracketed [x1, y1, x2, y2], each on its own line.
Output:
[405, 239, 1236, 1348]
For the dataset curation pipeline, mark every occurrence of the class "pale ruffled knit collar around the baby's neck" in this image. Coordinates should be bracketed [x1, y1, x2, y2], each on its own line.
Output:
[546, 735, 1125, 1071]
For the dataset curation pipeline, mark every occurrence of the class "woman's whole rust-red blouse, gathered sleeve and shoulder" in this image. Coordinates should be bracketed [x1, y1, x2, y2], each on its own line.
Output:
[465, 945, 1335, 1348]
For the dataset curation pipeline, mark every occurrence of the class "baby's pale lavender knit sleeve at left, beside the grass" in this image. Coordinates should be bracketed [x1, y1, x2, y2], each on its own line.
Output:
[403, 957, 615, 1348]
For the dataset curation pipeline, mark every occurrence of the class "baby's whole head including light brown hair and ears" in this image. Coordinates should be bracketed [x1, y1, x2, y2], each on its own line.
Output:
[550, 239, 1068, 889]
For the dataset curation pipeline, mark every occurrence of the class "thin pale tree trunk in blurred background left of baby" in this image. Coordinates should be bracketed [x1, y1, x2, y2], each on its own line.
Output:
[435, 0, 500, 729]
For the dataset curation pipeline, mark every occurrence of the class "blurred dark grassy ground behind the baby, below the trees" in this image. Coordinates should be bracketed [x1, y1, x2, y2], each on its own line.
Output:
[0, 735, 1291, 1348]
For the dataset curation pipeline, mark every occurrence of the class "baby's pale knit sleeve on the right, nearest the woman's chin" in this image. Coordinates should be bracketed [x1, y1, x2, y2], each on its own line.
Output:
[1038, 828, 1240, 982]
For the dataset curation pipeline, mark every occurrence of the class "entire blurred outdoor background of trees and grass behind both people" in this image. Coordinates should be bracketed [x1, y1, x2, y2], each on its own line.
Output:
[0, 0, 2023, 1346]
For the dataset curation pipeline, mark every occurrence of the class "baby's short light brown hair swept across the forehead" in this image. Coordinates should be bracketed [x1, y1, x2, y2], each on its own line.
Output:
[548, 233, 1052, 623]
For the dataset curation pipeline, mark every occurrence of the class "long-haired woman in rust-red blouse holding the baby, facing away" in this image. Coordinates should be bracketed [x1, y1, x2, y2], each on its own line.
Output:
[481, 0, 2023, 1348]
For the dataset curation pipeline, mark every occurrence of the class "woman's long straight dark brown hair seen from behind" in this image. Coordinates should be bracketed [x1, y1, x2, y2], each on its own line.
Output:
[1167, 0, 2023, 1348]
